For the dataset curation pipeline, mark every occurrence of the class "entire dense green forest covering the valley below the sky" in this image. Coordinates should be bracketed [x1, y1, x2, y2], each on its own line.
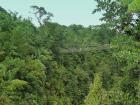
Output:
[0, 0, 140, 105]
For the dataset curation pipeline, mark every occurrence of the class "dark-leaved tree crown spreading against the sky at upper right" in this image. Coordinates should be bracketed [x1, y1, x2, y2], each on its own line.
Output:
[92, 0, 132, 32]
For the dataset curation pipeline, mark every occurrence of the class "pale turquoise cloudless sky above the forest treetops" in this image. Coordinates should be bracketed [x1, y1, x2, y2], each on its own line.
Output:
[0, 0, 102, 26]
